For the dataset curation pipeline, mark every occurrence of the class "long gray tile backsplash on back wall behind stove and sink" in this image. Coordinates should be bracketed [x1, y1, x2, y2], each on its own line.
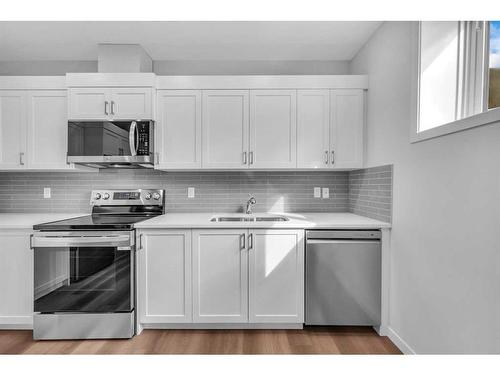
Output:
[0, 169, 349, 212]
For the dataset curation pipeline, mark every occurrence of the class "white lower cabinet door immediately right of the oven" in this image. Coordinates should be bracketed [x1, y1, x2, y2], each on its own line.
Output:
[138, 230, 193, 323]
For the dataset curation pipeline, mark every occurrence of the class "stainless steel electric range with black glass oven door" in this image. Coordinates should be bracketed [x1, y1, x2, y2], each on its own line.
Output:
[31, 189, 165, 340]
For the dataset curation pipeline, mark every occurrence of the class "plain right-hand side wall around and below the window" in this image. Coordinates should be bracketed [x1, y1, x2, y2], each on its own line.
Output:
[351, 22, 500, 353]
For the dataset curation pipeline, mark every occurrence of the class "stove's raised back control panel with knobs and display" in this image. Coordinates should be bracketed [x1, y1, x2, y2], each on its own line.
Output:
[90, 189, 165, 206]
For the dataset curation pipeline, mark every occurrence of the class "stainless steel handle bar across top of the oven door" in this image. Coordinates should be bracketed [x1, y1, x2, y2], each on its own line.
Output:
[31, 235, 134, 250]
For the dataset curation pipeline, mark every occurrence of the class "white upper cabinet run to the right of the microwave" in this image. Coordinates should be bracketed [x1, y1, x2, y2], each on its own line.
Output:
[150, 81, 366, 170]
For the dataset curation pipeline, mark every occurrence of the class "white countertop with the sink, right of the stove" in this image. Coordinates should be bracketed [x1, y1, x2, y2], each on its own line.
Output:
[134, 212, 391, 229]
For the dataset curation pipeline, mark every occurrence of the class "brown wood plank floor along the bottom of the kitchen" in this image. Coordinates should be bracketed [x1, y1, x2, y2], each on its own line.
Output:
[0, 327, 401, 354]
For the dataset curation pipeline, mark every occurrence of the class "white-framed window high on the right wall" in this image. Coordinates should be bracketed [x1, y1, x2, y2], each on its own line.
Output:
[412, 21, 500, 141]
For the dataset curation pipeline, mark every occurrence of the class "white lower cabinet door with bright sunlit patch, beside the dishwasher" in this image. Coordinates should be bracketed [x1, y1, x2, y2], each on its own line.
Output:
[249, 230, 304, 323]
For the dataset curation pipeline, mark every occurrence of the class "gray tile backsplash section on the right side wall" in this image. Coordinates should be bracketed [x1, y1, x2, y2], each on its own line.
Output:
[349, 165, 392, 222]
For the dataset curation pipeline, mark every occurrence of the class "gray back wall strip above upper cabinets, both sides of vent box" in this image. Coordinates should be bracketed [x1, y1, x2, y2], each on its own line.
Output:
[0, 60, 349, 76]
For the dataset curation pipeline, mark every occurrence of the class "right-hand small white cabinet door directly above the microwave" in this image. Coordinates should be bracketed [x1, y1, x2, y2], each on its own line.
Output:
[110, 87, 153, 120]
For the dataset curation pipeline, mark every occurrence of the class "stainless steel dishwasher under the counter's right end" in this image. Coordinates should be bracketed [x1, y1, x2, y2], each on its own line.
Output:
[305, 230, 381, 326]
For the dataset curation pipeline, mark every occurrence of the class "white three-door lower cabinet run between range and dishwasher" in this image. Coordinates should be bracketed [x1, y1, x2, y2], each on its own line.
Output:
[137, 228, 304, 327]
